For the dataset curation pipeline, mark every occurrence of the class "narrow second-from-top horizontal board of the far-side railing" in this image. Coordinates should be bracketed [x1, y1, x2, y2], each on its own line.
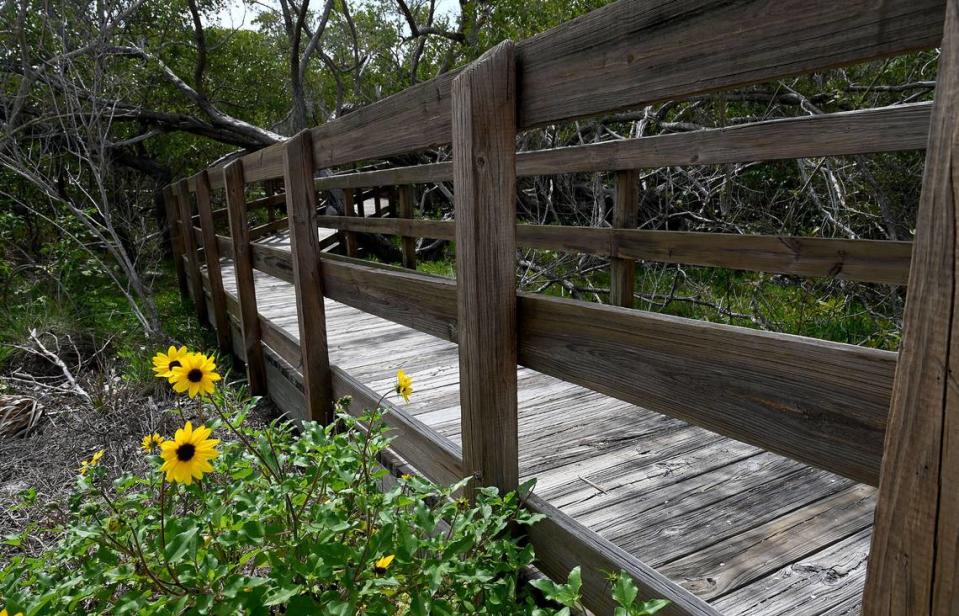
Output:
[304, 216, 912, 285]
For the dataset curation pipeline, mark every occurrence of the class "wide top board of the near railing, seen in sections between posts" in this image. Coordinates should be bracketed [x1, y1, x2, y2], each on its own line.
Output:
[176, 0, 945, 188]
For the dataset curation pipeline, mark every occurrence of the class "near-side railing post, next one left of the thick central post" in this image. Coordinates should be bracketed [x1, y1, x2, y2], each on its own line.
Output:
[283, 130, 333, 423]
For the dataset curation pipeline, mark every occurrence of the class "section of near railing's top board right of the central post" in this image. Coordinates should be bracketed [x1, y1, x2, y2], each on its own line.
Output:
[517, 0, 945, 128]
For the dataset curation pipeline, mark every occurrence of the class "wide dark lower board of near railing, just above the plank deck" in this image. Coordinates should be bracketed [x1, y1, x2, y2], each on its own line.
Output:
[246, 247, 896, 485]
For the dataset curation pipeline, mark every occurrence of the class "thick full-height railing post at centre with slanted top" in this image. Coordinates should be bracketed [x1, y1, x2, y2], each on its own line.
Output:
[453, 41, 519, 494]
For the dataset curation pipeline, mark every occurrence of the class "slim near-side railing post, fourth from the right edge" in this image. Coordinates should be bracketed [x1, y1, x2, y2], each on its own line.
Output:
[223, 159, 266, 396]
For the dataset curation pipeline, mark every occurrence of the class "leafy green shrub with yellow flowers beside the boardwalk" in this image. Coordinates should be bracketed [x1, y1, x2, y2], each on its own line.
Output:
[0, 348, 665, 616]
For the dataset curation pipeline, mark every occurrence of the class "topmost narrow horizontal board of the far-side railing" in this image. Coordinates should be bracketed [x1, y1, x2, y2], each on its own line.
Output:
[316, 103, 932, 190]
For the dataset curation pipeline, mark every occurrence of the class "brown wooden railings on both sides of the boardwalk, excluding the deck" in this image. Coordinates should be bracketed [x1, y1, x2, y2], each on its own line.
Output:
[159, 0, 959, 614]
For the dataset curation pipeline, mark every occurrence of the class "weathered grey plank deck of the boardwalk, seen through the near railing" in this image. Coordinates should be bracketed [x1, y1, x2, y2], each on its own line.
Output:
[206, 230, 875, 616]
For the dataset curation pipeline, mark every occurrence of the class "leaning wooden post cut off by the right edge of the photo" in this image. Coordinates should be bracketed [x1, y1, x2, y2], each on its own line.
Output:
[863, 0, 959, 616]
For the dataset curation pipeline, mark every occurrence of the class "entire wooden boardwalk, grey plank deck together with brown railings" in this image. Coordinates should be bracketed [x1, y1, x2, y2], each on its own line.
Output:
[164, 0, 959, 616]
